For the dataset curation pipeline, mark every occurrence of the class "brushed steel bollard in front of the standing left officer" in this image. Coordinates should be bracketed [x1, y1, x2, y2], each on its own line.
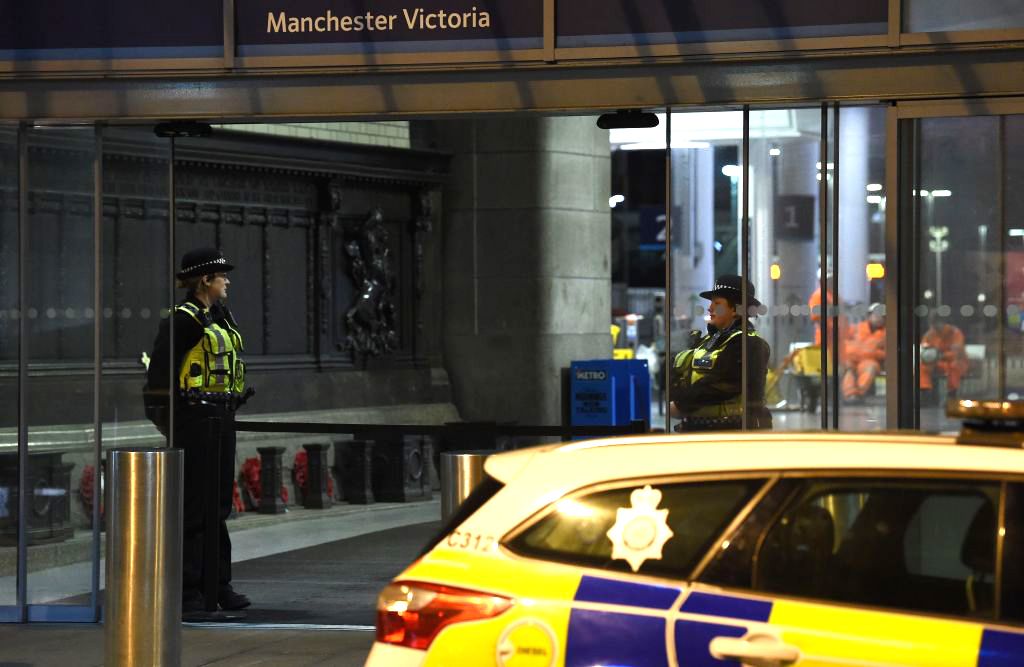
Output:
[103, 449, 184, 667]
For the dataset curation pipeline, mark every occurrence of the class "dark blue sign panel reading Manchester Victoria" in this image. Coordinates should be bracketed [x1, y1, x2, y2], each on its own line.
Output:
[236, 0, 544, 56]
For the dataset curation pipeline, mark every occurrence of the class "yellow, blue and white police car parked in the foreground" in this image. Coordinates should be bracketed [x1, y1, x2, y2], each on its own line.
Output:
[367, 402, 1024, 667]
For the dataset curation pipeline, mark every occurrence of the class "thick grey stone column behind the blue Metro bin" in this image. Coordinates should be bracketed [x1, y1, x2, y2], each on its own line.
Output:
[433, 117, 611, 424]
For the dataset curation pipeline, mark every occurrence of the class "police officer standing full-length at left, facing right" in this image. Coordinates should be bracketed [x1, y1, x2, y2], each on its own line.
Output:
[146, 248, 251, 618]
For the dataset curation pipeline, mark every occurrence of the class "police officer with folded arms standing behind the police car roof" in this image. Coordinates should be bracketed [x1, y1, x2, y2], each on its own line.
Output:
[670, 276, 771, 432]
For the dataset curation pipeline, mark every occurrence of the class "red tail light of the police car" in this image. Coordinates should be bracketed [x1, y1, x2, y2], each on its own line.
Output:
[377, 581, 512, 651]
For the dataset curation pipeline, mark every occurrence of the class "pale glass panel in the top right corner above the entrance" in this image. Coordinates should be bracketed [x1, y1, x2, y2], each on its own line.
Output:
[903, 0, 1024, 33]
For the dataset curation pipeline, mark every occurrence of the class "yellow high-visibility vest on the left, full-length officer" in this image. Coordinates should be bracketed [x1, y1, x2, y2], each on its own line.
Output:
[176, 302, 245, 393]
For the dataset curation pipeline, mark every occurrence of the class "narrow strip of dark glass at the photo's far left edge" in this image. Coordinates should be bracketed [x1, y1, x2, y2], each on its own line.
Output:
[0, 127, 19, 607]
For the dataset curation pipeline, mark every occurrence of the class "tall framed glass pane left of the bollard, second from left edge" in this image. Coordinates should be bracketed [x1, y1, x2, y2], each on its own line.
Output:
[20, 127, 95, 605]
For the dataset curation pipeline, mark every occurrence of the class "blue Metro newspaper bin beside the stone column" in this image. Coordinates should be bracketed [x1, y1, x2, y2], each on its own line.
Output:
[569, 359, 650, 426]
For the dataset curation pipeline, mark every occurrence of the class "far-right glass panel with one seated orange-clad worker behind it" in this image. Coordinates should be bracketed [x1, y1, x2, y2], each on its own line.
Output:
[898, 102, 1024, 430]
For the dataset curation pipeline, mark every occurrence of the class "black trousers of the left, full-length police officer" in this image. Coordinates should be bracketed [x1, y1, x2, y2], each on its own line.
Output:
[174, 405, 236, 595]
